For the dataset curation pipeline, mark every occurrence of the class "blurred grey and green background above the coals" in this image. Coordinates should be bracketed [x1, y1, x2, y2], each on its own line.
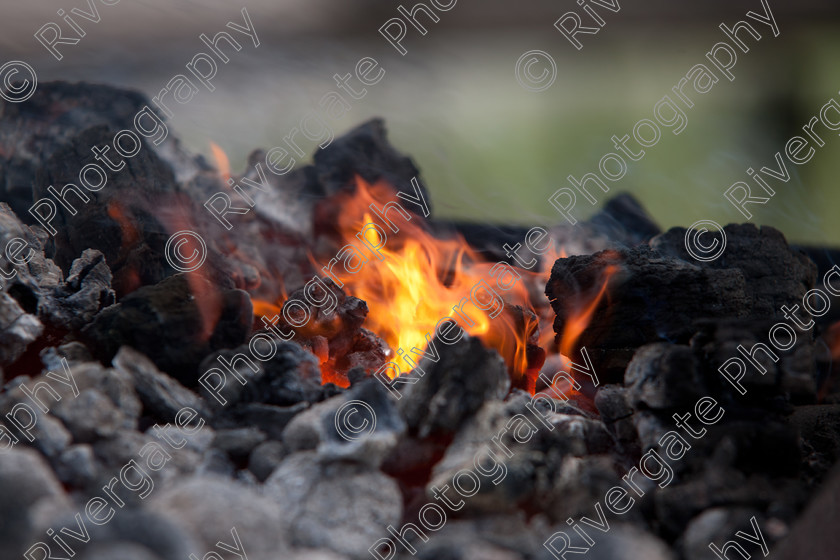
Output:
[0, 0, 840, 245]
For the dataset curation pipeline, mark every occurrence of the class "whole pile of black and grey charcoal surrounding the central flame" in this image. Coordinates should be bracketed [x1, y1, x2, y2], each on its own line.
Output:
[0, 83, 840, 560]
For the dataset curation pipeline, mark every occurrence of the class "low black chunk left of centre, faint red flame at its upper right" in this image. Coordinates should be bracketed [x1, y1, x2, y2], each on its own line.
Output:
[81, 274, 253, 386]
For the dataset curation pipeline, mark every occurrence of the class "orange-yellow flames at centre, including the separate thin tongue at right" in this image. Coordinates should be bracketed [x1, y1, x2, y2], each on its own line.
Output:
[262, 178, 609, 393]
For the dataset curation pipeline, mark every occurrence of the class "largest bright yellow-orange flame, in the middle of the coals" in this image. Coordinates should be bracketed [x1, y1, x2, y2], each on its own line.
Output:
[322, 179, 537, 379]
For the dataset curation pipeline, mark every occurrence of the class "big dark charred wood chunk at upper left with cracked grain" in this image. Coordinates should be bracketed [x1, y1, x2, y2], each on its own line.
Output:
[34, 122, 234, 296]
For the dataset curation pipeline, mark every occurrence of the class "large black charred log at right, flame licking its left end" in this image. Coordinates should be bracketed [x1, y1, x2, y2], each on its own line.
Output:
[546, 225, 816, 378]
